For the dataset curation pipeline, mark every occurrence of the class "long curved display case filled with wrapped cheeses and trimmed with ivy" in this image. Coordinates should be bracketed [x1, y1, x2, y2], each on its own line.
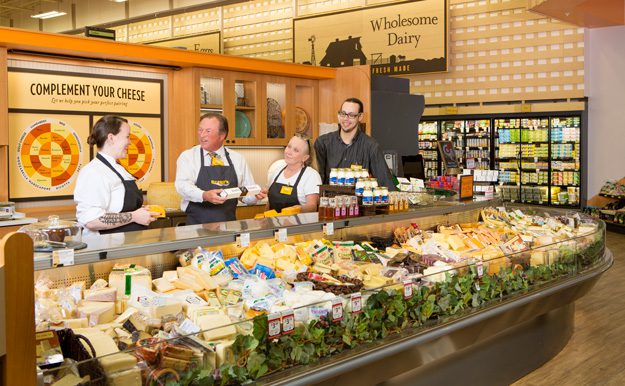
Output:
[0, 200, 612, 385]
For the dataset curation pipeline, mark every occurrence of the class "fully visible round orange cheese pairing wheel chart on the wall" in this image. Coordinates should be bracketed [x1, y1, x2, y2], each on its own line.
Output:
[17, 118, 82, 191]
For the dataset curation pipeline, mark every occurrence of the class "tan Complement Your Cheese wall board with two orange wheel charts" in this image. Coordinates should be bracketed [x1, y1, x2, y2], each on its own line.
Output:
[8, 65, 164, 200]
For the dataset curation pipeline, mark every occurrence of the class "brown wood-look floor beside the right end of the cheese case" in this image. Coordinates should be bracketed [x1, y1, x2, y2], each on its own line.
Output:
[513, 232, 625, 386]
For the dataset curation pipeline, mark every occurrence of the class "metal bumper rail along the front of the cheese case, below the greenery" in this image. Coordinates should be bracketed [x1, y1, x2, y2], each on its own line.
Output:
[270, 248, 614, 386]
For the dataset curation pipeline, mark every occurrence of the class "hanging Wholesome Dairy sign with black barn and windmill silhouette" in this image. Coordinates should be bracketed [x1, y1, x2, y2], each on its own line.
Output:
[293, 0, 447, 75]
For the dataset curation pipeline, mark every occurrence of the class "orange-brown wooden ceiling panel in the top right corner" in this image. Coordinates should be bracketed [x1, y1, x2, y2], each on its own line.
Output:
[530, 0, 625, 28]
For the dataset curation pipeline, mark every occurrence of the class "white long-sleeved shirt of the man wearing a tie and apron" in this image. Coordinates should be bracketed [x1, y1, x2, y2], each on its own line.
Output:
[176, 145, 257, 211]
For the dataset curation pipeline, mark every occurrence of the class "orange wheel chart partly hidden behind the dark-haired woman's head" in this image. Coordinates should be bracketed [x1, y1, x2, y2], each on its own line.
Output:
[119, 121, 155, 182]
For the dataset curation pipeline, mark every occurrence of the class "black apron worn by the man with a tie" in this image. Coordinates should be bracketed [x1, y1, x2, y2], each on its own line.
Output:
[185, 147, 239, 225]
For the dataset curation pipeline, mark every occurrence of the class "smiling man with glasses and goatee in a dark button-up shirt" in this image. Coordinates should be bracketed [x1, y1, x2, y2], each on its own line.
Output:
[315, 98, 395, 190]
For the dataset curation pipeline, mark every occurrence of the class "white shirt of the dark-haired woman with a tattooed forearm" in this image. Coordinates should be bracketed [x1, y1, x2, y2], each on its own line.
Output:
[74, 153, 135, 234]
